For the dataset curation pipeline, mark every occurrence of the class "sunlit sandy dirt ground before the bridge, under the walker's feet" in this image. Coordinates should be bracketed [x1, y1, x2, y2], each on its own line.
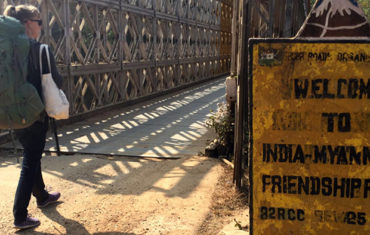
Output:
[0, 153, 249, 235]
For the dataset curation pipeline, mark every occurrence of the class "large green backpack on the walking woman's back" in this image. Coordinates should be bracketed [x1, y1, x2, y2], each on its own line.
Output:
[0, 16, 44, 129]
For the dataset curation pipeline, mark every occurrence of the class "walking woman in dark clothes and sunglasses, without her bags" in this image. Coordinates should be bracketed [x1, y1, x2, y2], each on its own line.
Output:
[4, 5, 62, 229]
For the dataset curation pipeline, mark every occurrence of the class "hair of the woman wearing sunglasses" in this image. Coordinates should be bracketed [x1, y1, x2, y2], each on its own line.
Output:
[3, 5, 40, 24]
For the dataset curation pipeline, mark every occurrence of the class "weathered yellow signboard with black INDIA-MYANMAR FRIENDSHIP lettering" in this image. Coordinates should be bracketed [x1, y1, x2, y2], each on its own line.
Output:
[250, 40, 370, 235]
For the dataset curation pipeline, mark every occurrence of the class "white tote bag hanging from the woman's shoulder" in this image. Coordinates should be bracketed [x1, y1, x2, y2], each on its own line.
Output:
[40, 44, 69, 120]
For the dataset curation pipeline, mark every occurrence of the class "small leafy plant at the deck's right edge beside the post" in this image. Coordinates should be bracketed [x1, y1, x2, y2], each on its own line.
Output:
[206, 103, 234, 145]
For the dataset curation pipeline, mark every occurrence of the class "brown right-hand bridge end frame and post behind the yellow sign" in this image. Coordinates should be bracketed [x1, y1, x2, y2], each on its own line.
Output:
[230, 0, 311, 191]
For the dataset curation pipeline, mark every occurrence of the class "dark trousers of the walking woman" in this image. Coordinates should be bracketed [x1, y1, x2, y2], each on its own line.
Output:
[13, 117, 49, 223]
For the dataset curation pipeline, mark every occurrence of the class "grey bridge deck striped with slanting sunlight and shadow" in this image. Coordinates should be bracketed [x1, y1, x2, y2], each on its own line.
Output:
[1, 78, 225, 158]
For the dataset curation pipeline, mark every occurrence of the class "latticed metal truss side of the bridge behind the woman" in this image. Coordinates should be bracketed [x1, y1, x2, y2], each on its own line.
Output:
[0, 0, 232, 115]
